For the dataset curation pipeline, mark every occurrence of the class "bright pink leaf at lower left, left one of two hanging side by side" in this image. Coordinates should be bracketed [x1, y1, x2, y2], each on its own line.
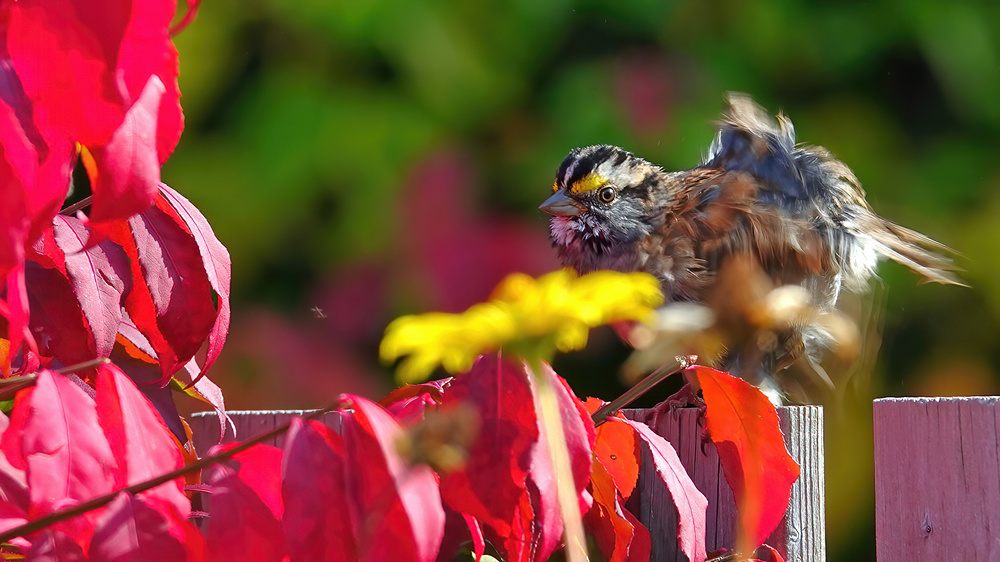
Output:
[19, 370, 117, 545]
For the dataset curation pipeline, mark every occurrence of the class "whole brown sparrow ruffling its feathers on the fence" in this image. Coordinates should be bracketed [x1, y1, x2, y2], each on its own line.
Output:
[539, 93, 963, 403]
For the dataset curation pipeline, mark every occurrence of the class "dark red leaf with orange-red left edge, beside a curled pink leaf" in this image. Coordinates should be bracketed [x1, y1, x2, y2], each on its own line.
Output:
[109, 201, 218, 378]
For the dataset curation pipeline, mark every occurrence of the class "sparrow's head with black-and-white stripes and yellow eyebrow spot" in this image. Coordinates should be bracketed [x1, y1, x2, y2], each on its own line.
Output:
[539, 144, 663, 273]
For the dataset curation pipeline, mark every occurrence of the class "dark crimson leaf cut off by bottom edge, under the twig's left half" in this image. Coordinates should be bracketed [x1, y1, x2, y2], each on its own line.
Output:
[88, 492, 201, 562]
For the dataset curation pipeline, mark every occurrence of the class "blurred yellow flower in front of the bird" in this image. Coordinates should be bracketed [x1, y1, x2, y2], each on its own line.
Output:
[379, 269, 663, 382]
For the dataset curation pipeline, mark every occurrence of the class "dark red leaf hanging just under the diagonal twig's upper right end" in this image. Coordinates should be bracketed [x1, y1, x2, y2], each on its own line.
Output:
[281, 418, 356, 562]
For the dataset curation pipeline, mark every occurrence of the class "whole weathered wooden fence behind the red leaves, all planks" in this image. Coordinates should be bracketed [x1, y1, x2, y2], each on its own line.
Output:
[190, 397, 1000, 562]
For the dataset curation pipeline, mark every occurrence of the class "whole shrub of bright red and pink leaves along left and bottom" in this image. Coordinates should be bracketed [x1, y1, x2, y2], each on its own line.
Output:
[0, 0, 798, 562]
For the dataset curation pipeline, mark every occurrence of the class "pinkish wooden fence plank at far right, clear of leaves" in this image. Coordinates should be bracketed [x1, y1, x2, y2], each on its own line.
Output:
[873, 396, 1000, 562]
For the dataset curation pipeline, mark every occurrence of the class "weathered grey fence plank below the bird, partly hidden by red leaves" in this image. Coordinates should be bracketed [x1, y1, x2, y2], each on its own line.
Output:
[626, 406, 826, 562]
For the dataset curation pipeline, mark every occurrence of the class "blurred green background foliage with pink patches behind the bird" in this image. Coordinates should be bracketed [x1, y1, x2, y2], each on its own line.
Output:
[164, 0, 1000, 560]
